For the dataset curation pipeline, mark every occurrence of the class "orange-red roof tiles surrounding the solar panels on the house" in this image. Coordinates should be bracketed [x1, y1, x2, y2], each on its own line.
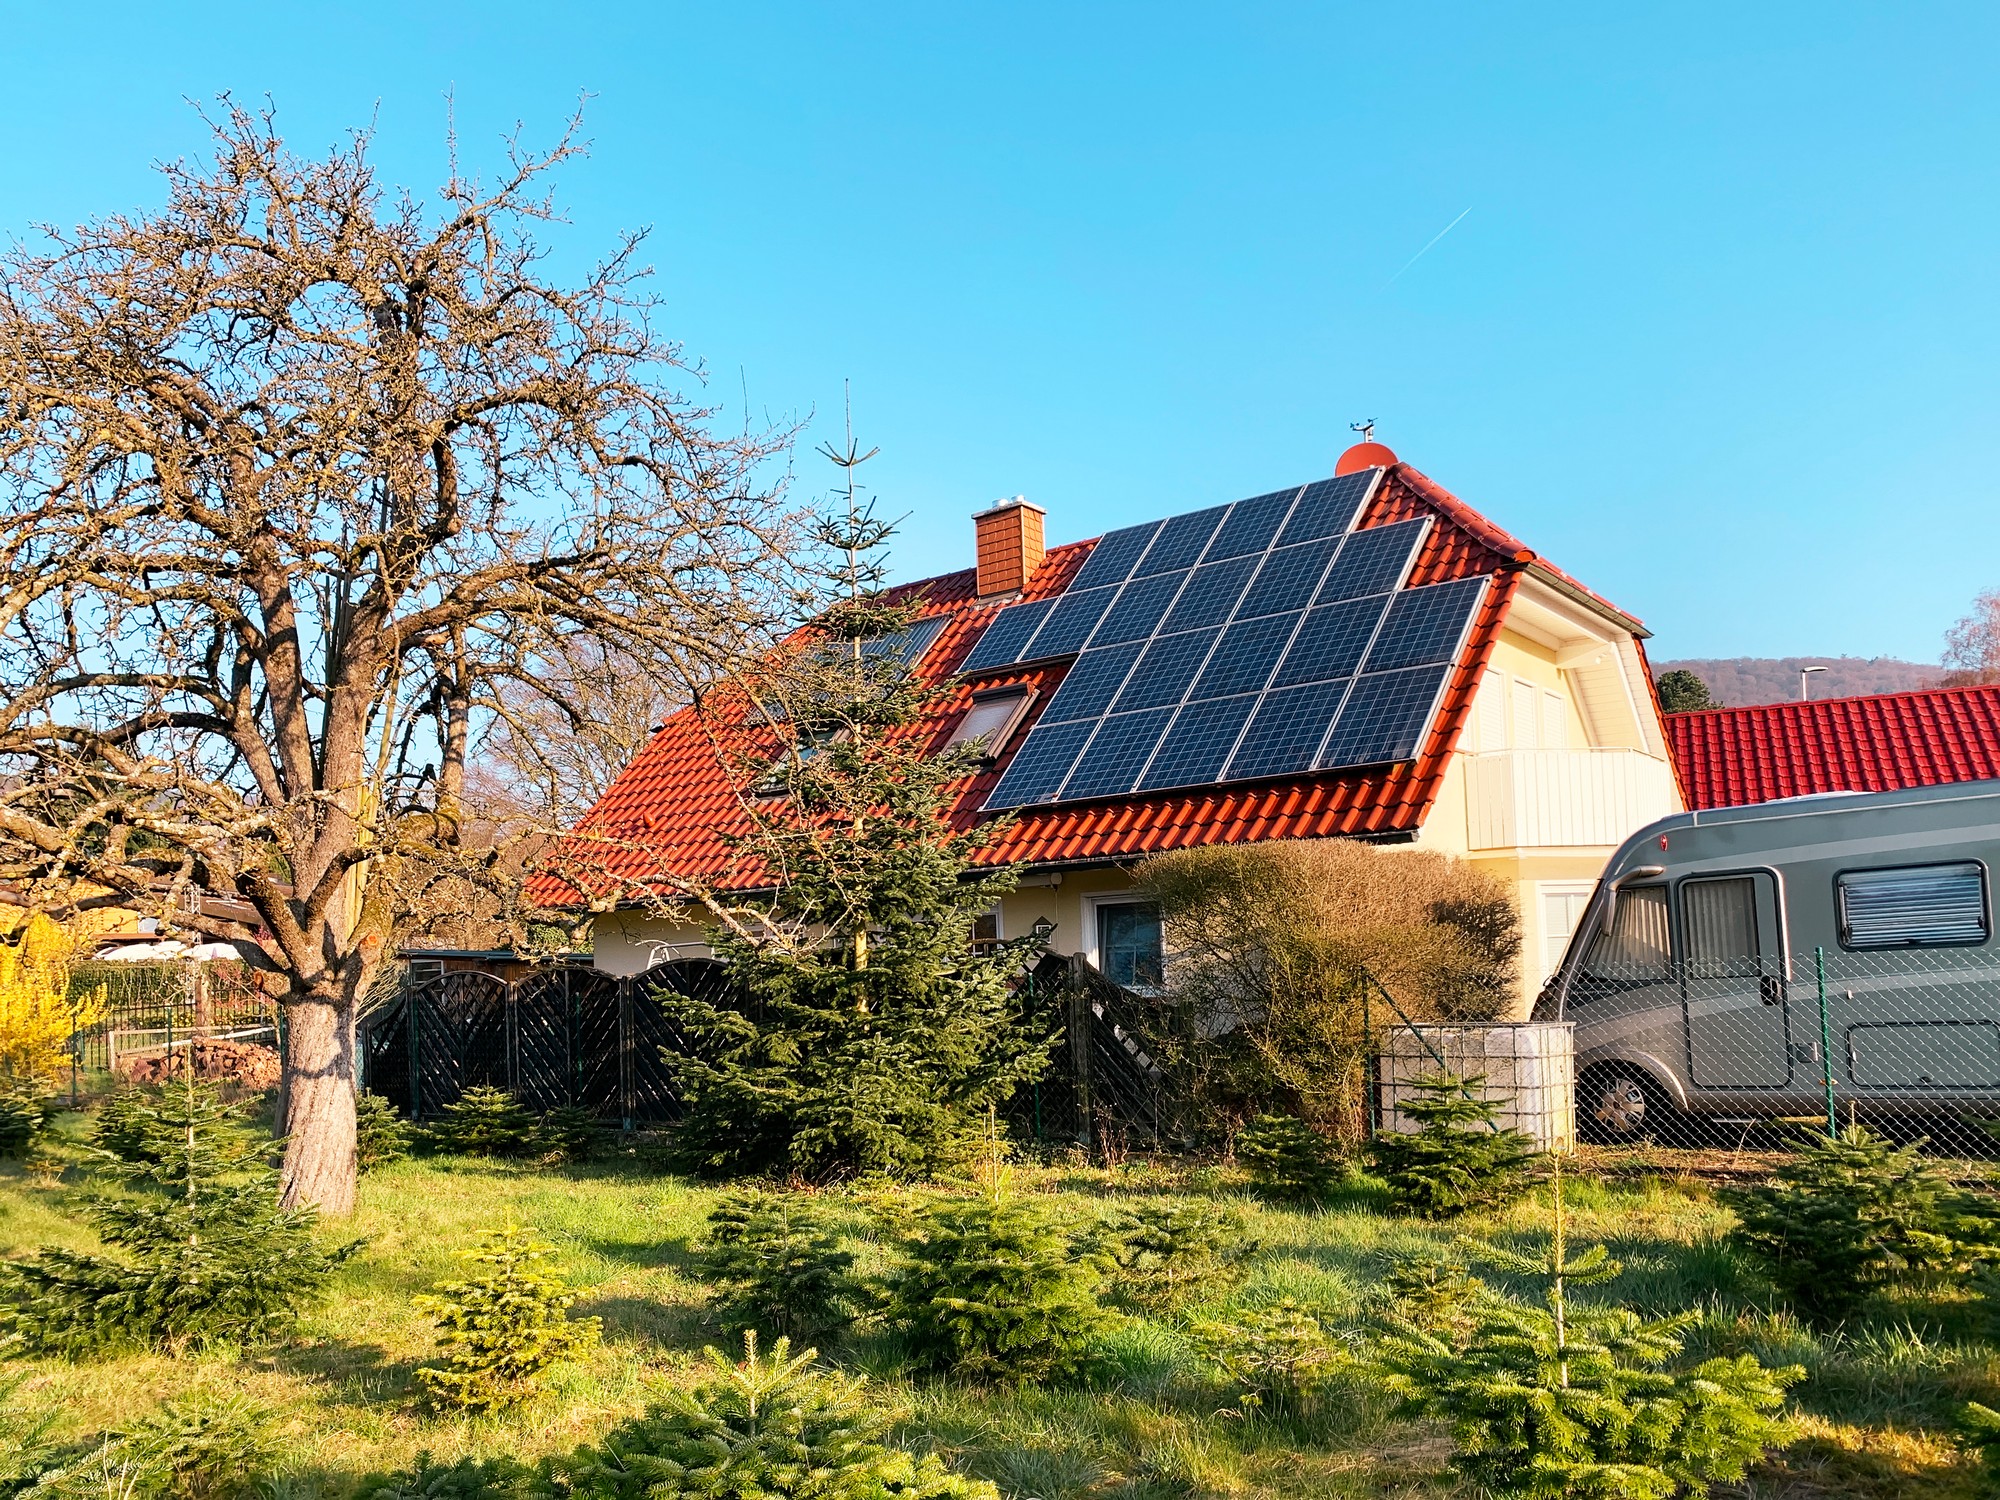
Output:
[530, 464, 1636, 904]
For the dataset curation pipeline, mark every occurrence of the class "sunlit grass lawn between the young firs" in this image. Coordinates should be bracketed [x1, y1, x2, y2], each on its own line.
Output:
[0, 1116, 2000, 1500]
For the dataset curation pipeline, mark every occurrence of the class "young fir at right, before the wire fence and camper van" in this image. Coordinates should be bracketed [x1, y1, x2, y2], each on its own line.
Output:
[1716, 1126, 1992, 1324]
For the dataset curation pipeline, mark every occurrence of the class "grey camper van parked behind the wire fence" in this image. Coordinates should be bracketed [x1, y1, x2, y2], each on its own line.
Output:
[1534, 782, 2000, 1142]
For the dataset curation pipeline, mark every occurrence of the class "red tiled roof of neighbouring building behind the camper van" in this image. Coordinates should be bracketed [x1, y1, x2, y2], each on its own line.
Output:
[1666, 686, 2000, 810]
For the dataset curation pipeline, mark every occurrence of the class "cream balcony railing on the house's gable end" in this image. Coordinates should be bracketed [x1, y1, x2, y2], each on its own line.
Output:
[1466, 750, 1676, 850]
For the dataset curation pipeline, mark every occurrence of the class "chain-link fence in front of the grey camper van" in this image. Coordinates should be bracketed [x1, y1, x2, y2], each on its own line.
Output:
[1536, 944, 2000, 1152]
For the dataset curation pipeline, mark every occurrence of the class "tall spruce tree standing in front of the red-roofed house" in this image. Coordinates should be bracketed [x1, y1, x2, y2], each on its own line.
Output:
[660, 426, 1048, 1182]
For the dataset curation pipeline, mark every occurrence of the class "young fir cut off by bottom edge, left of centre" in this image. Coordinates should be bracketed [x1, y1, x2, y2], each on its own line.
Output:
[544, 1334, 998, 1500]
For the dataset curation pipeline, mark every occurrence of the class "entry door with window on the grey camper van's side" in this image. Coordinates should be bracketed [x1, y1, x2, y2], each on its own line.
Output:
[1680, 870, 1792, 1088]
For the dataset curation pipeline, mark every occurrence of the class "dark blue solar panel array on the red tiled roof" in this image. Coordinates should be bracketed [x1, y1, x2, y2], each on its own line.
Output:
[960, 470, 1488, 810]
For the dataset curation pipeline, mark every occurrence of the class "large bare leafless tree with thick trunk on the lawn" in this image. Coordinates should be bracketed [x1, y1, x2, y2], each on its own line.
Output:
[0, 100, 794, 1214]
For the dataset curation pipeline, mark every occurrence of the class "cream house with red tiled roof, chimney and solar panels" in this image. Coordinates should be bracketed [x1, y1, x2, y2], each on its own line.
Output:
[532, 442, 1682, 1014]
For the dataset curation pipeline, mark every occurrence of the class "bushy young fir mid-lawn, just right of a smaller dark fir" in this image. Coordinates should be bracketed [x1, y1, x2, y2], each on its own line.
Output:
[884, 1194, 1108, 1382]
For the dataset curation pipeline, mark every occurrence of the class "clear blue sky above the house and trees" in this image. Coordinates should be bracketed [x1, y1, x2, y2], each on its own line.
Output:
[0, 2, 2000, 660]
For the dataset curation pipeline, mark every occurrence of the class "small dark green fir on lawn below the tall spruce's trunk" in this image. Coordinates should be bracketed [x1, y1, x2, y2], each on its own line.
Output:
[694, 1190, 860, 1336]
